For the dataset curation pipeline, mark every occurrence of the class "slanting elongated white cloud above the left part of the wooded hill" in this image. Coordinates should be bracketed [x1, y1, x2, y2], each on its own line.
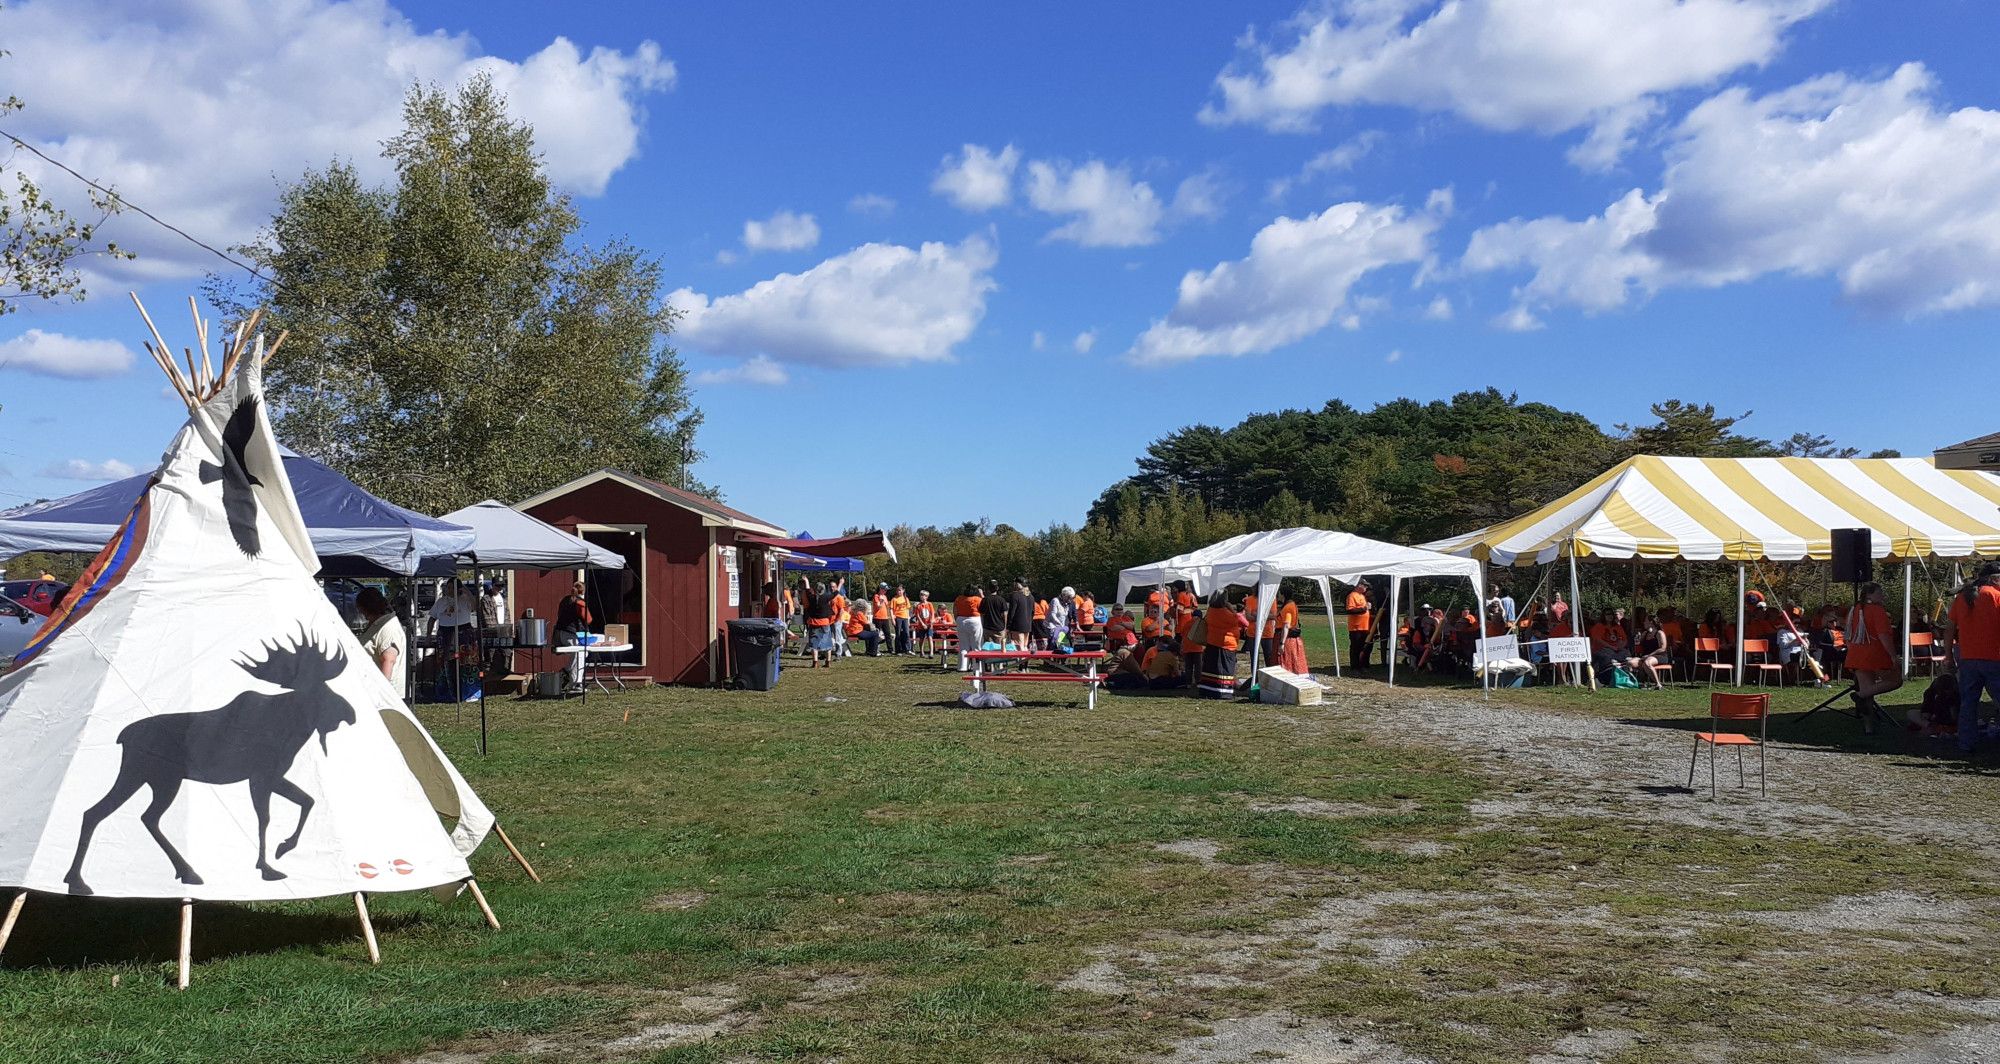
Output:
[1126, 202, 1438, 364]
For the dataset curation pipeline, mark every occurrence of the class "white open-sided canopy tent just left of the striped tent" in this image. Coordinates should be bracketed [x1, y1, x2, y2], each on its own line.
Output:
[1118, 528, 1492, 686]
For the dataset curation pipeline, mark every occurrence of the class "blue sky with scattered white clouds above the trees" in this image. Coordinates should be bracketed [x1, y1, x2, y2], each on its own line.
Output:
[0, 0, 2000, 530]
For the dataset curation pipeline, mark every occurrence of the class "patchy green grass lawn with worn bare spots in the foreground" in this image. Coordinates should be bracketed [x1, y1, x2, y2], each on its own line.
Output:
[0, 636, 1996, 1064]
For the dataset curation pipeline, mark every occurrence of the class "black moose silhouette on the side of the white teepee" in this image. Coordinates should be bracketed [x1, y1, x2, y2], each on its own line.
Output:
[64, 628, 354, 894]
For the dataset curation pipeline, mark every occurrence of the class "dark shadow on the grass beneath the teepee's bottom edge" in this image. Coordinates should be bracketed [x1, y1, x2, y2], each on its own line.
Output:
[0, 894, 422, 970]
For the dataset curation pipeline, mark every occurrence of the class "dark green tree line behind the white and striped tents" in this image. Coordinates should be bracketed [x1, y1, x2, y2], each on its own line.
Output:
[848, 388, 1896, 600]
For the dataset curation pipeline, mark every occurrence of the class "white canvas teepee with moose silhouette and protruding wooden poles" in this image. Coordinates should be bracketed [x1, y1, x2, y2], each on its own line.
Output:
[0, 298, 512, 986]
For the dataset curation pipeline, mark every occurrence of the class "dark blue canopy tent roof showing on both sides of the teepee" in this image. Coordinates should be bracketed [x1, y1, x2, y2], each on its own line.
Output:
[0, 450, 474, 576]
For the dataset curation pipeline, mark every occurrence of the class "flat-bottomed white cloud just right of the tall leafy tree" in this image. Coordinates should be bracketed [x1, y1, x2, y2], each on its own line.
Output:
[668, 236, 1000, 366]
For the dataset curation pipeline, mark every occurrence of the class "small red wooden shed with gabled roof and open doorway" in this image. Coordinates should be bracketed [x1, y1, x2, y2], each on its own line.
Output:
[512, 470, 784, 684]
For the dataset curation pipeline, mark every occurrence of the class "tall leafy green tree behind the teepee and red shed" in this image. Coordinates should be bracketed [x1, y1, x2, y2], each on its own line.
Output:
[210, 78, 704, 514]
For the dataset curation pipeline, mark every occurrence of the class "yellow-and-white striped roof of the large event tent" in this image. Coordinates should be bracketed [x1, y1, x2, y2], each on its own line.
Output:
[1422, 456, 2000, 566]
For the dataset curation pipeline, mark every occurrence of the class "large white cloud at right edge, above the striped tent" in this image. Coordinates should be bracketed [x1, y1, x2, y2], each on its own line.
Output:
[1464, 64, 2000, 318]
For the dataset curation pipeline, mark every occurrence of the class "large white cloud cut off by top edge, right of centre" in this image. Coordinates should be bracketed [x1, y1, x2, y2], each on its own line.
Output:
[1200, 0, 1832, 164]
